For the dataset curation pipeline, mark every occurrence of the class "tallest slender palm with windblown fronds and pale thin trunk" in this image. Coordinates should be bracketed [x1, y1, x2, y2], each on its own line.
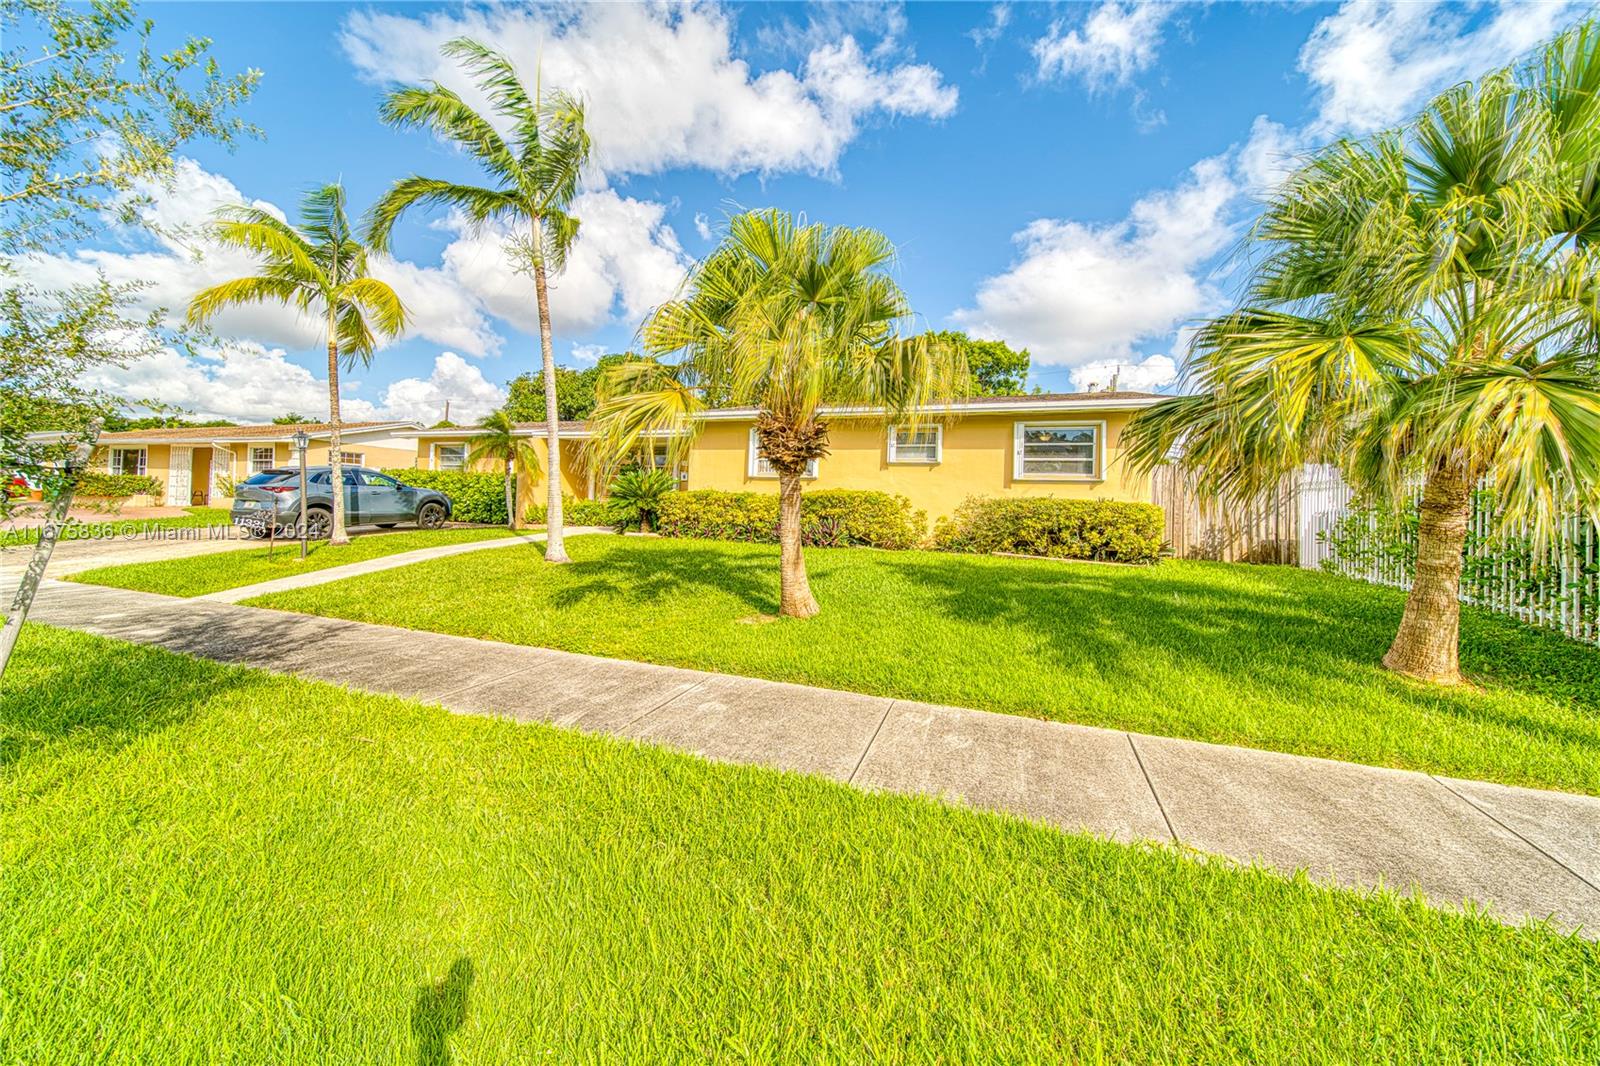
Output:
[366, 37, 590, 562]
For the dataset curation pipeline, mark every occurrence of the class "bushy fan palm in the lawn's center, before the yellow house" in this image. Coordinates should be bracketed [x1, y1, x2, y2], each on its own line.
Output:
[592, 210, 968, 618]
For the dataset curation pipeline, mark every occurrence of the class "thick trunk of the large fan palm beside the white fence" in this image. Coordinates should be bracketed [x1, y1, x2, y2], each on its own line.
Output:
[1384, 463, 1472, 685]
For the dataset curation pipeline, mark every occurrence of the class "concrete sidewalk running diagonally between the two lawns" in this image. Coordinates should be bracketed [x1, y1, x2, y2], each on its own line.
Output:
[15, 581, 1600, 938]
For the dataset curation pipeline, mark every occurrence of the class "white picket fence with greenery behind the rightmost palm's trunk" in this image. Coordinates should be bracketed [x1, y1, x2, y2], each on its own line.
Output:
[1298, 467, 1600, 643]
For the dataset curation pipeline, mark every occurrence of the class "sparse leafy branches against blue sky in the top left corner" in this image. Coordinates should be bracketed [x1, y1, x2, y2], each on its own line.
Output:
[0, 0, 261, 253]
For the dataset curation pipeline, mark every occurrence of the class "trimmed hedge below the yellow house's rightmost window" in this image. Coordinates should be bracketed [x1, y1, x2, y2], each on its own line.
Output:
[933, 496, 1165, 562]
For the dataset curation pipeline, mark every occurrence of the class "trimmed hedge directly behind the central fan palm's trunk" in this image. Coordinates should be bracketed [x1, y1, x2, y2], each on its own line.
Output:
[656, 488, 928, 549]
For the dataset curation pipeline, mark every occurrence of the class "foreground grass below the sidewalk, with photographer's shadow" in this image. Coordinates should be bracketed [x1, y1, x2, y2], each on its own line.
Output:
[0, 617, 1600, 1064]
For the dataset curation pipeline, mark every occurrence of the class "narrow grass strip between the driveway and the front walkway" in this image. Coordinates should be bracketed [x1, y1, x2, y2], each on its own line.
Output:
[66, 527, 512, 595]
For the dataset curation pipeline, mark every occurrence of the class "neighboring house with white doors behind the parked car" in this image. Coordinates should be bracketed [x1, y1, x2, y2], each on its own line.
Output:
[91, 421, 421, 507]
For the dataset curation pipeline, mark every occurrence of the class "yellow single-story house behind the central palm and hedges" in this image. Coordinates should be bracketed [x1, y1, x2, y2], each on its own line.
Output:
[412, 392, 1163, 519]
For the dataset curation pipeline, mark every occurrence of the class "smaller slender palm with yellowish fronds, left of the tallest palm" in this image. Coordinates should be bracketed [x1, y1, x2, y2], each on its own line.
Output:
[189, 182, 406, 544]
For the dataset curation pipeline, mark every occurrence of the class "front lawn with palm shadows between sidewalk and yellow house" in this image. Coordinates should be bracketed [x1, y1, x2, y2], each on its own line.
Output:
[251, 536, 1600, 794]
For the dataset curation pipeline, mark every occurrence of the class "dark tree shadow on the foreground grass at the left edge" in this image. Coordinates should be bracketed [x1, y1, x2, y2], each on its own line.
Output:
[0, 624, 248, 765]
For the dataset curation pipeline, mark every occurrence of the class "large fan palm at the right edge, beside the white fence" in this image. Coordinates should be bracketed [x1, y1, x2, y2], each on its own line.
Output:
[1123, 24, 1600, 683]
